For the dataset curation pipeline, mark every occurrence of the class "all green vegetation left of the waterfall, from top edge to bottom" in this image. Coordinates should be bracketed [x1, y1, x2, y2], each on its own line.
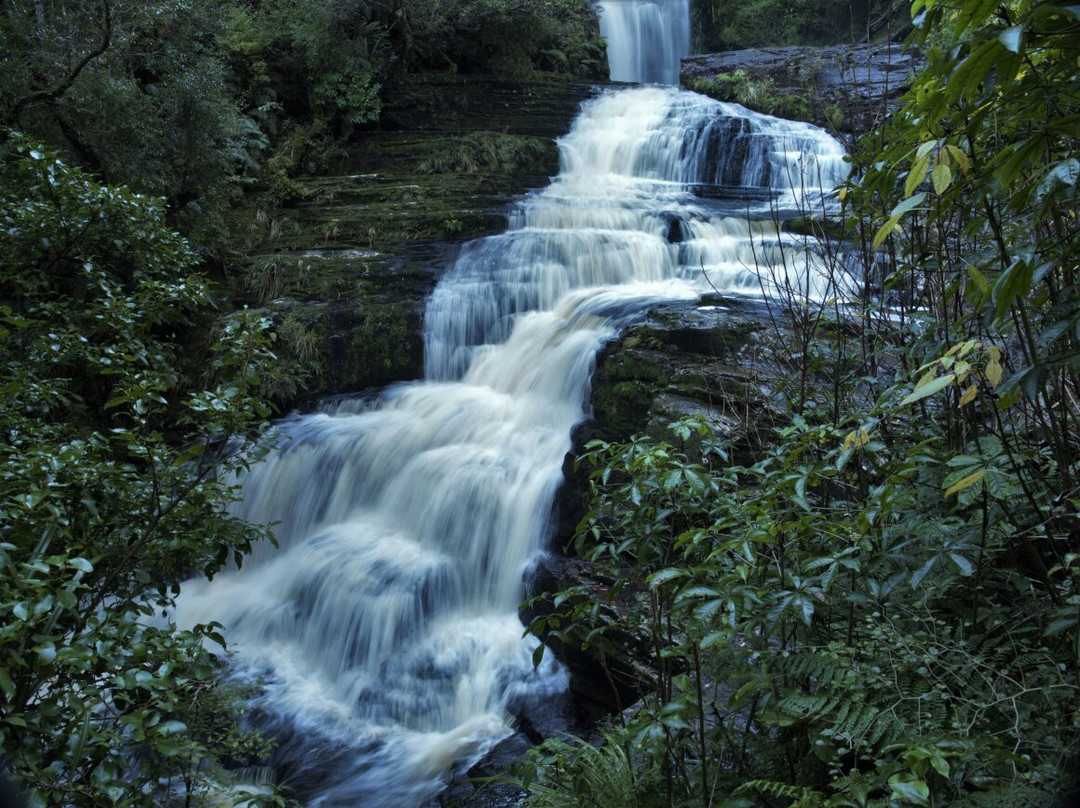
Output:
[0, 0, 603, 806]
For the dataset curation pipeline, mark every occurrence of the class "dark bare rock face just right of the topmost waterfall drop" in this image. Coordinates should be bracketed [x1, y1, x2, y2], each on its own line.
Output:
[681, 43, 919, 135]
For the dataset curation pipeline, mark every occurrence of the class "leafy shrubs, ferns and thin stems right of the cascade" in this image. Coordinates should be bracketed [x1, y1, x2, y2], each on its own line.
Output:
[523, 0, 1080, 808]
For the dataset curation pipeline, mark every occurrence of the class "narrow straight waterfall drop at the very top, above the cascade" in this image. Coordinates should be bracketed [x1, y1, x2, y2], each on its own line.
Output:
[596, 0, 690, 84]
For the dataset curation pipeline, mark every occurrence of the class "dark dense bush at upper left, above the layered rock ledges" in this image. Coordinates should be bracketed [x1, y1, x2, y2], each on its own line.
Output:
[0, 0, 605, 253]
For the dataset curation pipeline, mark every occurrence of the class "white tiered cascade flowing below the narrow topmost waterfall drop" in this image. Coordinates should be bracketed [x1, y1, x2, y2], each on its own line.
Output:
[177, 3, 845, 808]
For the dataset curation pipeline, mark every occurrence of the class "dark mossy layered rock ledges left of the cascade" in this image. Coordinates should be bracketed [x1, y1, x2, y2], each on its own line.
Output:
[225, 75, 592, 406]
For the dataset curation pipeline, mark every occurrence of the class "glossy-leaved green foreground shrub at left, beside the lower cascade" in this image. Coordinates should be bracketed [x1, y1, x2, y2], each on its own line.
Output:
[0, 135, 274, 806]
